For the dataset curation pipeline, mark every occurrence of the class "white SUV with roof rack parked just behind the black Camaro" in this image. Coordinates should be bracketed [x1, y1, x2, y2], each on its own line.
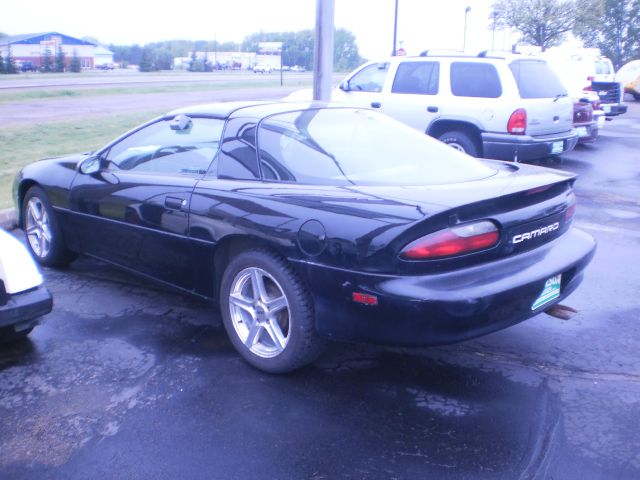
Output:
[298, 55, 577, 161]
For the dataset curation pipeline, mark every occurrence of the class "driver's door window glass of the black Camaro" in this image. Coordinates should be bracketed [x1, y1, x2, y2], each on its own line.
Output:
[104, 116, 224, 175]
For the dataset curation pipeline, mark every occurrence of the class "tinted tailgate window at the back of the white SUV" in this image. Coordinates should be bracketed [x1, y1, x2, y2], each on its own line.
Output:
[509, 60, 567, 98]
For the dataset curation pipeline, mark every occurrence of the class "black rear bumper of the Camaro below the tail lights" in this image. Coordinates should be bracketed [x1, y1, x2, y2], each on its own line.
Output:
[297, 228, 596, 346]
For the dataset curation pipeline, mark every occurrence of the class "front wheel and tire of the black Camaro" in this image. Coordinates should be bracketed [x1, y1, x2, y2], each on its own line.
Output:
[22, 186, 77, 267]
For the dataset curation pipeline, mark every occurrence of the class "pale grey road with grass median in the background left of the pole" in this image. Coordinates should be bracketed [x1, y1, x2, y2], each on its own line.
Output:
[0, 72, 320, 128]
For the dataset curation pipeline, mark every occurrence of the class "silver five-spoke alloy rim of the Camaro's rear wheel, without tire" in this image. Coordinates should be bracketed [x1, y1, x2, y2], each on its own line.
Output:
[229, 267, 291, 358]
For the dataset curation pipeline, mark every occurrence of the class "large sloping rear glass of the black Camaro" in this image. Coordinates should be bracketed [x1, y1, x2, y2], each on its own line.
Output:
[258, 108, 496, 186]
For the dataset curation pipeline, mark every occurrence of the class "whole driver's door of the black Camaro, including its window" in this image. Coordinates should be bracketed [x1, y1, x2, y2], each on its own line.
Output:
[70, 115, 224, 289]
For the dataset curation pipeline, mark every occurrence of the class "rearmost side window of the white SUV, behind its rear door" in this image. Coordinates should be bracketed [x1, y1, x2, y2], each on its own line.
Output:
[451, 62, 502, 98]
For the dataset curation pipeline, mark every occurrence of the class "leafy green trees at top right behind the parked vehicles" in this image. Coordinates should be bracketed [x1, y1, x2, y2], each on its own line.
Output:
[489, 0, 640, 69]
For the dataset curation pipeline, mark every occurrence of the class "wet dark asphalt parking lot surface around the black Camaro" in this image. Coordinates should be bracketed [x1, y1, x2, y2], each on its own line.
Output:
[0, 102, 640, 480]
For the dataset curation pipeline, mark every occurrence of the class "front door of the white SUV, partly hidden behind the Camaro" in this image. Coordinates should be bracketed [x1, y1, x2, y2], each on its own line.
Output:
[331, 62, 390, 108]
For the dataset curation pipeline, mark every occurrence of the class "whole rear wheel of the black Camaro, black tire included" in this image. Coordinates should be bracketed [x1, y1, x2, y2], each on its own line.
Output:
[220, 249, 324, 373]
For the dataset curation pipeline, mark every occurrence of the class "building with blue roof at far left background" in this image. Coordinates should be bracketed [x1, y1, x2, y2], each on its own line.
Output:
[0, 32, 98, 68]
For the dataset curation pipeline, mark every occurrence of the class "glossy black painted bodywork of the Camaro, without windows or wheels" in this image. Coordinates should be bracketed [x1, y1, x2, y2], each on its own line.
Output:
[14, 105, 595, 344]
